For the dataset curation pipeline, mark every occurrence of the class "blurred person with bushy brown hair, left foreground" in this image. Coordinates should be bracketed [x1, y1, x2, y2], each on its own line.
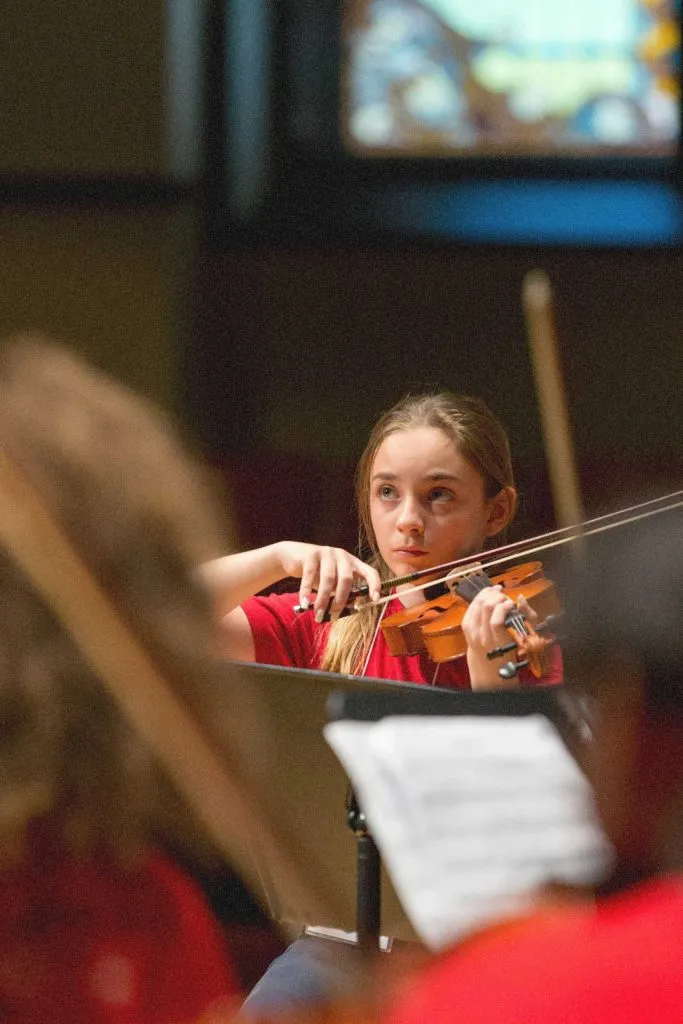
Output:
[0, 336, 238, 1024]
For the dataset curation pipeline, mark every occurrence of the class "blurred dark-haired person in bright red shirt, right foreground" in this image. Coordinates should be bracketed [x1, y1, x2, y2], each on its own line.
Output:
[382, 509, 683, 1024]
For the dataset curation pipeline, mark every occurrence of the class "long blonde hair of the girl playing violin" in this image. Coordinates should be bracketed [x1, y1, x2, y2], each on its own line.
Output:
[321, 391, 514, 675]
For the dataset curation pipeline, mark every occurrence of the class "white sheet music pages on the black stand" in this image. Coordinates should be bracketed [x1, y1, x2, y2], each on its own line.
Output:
[325, 715, 611, 948]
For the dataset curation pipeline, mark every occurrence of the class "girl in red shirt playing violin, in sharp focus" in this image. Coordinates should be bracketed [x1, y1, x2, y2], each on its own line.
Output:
[203, 392, 561, 689]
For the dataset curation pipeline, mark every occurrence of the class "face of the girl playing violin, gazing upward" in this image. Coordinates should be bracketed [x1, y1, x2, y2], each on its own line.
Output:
[370, 427, 514, 575]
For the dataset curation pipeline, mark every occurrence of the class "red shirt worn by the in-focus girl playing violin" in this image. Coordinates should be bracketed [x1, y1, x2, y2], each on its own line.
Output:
[242, 594, 562, 690]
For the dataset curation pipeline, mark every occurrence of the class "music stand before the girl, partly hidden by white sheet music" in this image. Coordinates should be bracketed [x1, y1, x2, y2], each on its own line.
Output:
[211, 663, 577, 941]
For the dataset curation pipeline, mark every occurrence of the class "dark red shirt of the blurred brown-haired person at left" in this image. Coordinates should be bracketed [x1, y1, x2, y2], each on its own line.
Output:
[0, 835, 239, 1024]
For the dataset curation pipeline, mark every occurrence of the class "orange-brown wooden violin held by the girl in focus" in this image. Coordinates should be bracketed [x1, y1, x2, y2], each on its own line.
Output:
[380, 561, 562, 679]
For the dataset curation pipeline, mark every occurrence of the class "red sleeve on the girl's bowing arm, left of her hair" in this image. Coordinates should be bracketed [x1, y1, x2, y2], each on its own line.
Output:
[242, 594, 329, 669]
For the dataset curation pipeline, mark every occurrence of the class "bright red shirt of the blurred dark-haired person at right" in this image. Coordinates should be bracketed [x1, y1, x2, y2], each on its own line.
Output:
[383, 879, 683, 1024]
